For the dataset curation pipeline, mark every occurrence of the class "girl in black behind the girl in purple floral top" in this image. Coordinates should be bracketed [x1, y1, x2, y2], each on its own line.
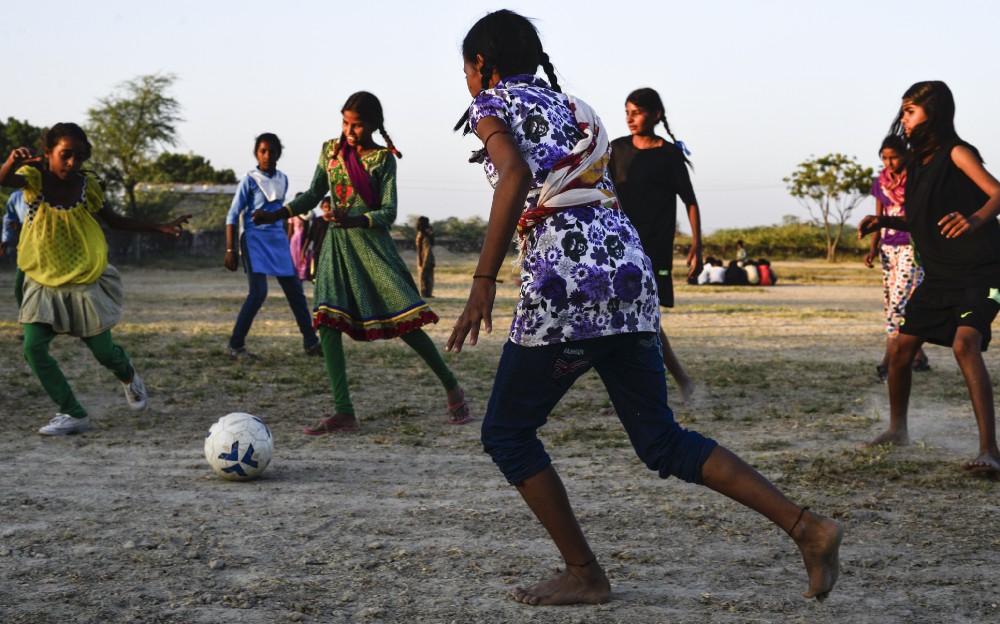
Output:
[608, 87, 702, 401]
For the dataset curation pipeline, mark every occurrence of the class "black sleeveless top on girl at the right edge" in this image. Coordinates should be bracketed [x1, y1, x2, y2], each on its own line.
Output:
[905, 141, 1000, 289]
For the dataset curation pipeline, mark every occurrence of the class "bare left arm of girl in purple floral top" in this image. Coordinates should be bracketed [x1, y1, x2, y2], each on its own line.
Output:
[445, 117, 531, 353]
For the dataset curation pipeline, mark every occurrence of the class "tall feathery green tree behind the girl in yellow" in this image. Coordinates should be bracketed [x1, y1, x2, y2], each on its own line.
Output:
[87, 74, 181, 217]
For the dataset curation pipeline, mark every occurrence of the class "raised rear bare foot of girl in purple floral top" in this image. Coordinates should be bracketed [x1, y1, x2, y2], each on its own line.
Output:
[791, 511, 844, 602]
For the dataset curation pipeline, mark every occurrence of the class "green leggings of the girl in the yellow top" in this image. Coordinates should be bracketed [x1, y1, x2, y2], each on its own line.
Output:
[24, 323, 133, 418]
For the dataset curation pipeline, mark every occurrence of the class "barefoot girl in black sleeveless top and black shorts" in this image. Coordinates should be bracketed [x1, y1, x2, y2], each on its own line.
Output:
[858, 80, 1000, 472]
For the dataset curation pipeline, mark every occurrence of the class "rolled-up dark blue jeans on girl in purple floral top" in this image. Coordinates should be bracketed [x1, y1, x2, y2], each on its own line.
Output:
[482, 333, 717, 485]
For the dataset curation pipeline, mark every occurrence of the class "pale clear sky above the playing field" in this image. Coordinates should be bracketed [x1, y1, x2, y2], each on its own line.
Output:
[0, 0, 1000, 233]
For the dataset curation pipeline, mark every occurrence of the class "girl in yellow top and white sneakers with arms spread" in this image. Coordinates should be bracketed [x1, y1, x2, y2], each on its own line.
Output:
[0, 123, 188, 435]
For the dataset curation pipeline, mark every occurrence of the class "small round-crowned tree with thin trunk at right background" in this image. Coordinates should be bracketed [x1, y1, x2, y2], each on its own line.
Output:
[783, 154, 875, 262]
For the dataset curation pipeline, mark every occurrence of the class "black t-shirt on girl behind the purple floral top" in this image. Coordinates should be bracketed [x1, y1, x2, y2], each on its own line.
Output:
[609, 135, 698, 270]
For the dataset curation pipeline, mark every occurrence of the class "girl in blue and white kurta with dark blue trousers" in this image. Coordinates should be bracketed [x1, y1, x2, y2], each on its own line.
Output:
[225, 132, 322, 359]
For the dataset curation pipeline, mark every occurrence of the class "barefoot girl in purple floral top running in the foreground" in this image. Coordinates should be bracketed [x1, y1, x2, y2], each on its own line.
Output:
[447, 11, 843, 605]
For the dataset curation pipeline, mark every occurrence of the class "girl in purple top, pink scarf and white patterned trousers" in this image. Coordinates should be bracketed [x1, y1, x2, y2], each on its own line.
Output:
[865, 134, 930, 383]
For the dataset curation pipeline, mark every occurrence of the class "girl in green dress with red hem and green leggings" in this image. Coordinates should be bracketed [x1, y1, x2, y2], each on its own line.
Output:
[253, 91, 470, 435]
